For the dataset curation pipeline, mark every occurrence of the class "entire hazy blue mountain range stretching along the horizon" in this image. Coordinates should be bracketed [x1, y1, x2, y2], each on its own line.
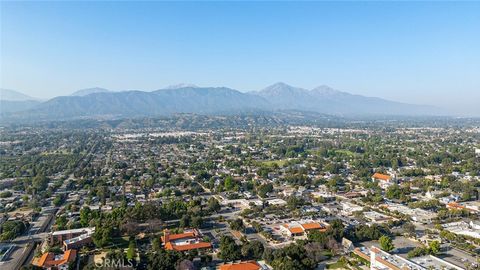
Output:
[1, 83, 442, 120]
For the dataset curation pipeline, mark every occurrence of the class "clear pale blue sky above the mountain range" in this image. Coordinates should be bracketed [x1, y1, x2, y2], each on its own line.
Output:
[0, 1, 480, 116]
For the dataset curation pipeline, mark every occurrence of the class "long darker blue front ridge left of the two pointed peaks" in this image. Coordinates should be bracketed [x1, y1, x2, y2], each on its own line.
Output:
[15, 87, 268, 119]
